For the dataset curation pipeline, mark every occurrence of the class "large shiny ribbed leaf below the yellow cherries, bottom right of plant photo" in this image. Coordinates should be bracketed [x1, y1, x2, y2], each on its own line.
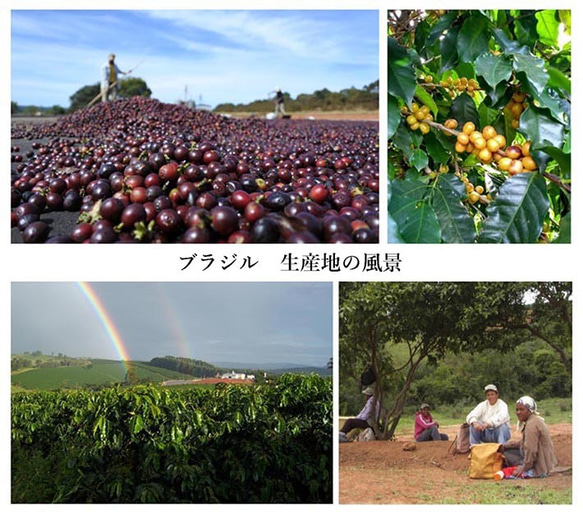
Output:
[479, 173, 549, 243]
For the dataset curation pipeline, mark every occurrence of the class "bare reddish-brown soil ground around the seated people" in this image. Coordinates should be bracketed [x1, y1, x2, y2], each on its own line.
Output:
[339, 424, 572, 504]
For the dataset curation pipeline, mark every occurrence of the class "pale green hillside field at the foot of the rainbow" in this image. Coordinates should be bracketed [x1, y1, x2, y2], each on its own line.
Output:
[12, 359, 191, 390]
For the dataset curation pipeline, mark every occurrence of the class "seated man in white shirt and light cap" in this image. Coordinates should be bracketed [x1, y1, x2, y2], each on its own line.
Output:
[466, 384, 510, 447]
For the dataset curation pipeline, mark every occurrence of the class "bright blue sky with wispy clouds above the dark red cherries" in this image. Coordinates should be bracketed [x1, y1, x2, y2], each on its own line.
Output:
[11, 10, 379, 107]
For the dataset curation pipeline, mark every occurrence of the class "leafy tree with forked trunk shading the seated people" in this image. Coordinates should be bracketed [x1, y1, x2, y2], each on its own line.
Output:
[339, 282, 571, 438]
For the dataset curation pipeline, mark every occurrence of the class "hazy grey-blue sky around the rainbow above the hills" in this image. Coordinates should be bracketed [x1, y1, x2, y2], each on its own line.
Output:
[12, 282, 332, 367]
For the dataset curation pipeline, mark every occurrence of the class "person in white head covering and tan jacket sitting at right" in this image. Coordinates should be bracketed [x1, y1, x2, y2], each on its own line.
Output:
[499, 396, 558, 478]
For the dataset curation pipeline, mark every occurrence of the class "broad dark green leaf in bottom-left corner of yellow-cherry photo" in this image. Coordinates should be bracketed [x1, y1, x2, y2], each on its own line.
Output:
[389, 180, 441, 243]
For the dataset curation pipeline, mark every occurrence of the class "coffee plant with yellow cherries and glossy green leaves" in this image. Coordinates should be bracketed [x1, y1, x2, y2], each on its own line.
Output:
[388, 10, 571, 243]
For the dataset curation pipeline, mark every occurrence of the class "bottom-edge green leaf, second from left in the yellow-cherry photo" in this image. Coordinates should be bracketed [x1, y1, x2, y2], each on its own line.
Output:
[432, 174, 476, 243]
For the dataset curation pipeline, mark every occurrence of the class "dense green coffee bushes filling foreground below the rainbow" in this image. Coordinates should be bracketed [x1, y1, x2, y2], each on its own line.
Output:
[12, 374, 332, 503]
